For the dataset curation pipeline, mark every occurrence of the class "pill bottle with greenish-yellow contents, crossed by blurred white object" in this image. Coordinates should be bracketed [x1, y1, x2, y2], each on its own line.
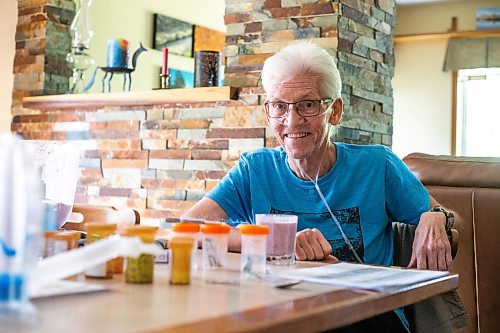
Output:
[122, 225, 158, 283]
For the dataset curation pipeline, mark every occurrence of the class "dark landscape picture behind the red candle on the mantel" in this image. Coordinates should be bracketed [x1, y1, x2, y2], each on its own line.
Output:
[153, 14, 194, 57]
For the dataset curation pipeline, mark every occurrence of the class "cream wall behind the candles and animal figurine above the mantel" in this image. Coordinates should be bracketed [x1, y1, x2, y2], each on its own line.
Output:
[88, 0, 226, 92]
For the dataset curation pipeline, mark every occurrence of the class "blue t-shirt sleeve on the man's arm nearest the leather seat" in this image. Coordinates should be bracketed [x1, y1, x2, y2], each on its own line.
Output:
[385, 149, 430, 224]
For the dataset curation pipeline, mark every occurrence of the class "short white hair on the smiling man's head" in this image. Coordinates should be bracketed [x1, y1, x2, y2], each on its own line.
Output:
[261, 42, 342, 99]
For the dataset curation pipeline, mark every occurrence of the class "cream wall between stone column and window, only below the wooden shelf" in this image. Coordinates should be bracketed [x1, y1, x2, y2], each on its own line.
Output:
[392, 41, 451, 157]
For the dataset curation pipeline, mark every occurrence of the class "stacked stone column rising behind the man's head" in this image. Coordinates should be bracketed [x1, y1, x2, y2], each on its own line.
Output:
[224, 0, 395, 146]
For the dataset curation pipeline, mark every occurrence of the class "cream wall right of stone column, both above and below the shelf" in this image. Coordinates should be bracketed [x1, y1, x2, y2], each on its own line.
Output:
[392, 0, 499, 157]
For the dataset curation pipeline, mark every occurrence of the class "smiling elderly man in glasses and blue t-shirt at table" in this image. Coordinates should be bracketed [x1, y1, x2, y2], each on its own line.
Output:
[183, 43, 453, 331]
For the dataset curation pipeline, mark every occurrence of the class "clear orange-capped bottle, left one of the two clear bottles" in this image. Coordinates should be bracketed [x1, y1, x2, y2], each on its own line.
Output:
[201, 223, 231, 269]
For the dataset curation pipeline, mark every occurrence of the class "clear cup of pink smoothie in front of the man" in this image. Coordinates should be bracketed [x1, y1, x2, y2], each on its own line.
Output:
[255, 214, 298, 266]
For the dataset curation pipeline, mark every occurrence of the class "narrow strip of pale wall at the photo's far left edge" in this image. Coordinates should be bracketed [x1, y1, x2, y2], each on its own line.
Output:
[0, 0, 17, 133]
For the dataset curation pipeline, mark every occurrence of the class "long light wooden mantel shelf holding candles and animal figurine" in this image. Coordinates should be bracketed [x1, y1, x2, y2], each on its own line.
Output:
[23, 86, 238, 110]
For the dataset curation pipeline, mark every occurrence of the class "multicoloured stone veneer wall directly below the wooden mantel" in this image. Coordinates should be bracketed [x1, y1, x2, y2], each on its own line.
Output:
[11, 88, 266, 225]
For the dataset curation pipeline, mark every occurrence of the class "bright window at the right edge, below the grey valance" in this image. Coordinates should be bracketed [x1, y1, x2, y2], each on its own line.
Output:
[456, 68, 500, 157]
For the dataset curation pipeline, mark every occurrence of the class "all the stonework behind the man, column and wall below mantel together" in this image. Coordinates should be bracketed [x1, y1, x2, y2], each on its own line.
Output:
[12, 0, 394, 224]
